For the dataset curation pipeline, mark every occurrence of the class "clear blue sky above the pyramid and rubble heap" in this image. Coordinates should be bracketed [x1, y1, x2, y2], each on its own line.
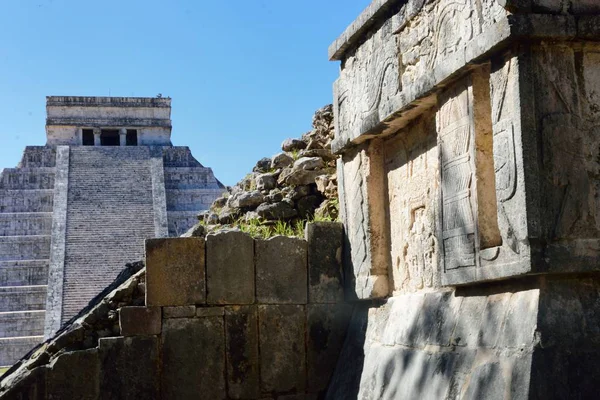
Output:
[0, 0, 370, 185]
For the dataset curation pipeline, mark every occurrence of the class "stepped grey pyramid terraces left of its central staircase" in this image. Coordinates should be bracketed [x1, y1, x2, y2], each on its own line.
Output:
[0, 147, 56, 367]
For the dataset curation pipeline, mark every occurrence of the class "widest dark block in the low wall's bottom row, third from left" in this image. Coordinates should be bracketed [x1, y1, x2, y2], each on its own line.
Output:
[161, 317, 227, 400]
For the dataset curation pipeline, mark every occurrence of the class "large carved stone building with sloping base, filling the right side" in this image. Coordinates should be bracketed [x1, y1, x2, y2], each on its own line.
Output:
[327, 0, 600, 399]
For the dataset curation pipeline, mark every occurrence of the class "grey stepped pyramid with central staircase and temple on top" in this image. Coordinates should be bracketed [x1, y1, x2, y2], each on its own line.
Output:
[0, 96, 224, 366]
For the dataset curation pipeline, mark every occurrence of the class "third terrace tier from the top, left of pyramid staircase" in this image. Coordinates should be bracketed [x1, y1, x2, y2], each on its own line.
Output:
[0, 189, 54, 213]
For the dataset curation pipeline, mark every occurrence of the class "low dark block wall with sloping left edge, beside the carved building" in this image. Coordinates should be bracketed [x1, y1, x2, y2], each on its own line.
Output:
[0, 223, 353, 399]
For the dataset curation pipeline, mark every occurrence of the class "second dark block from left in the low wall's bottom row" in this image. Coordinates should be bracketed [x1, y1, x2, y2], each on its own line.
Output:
[98, 336, 160, 400]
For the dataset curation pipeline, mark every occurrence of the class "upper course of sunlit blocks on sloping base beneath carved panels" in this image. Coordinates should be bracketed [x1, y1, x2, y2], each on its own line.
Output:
[376, 290, 539, 349]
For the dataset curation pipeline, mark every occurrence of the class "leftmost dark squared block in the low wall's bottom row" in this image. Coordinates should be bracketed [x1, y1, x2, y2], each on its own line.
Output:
[46, 349, 100, 400]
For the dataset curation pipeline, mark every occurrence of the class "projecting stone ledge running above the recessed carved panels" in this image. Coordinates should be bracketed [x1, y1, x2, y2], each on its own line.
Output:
[332, 14, 600, 154]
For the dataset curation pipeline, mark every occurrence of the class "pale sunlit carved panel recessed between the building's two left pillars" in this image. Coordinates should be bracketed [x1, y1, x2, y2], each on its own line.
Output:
[385, 116, 439, 293]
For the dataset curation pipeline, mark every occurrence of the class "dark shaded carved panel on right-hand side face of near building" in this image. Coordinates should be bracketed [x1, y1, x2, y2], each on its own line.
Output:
[533, 46, 600, 240]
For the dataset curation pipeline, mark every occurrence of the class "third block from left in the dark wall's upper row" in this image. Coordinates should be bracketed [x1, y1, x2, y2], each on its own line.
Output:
[256, 236, 307, 304]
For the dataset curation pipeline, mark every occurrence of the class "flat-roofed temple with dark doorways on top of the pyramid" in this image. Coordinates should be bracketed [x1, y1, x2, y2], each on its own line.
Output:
[46, 96, 172, 146]
